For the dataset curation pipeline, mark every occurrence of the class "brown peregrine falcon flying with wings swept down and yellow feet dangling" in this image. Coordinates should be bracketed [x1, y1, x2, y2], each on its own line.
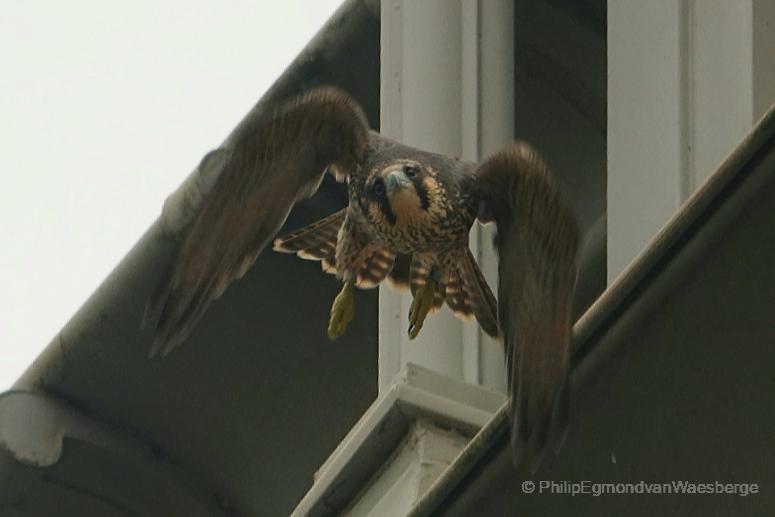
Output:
[146, 88, 578, 473]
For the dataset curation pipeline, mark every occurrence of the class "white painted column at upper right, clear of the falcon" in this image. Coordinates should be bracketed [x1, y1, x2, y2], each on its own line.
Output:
[608, 0, 775, 283]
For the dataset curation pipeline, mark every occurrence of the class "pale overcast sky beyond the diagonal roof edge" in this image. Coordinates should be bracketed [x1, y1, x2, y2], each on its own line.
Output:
[0, 0, 341, 389]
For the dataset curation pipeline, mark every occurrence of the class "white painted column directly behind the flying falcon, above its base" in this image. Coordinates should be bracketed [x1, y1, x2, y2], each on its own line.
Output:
[379, 0, 514, 392]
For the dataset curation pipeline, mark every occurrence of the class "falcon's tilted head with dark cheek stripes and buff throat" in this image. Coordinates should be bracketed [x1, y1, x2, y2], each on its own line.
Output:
[362, 159, 446, 229]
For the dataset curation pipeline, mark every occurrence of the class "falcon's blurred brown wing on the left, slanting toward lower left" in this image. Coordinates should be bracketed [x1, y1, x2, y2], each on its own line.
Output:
[145, 88, 369, 355]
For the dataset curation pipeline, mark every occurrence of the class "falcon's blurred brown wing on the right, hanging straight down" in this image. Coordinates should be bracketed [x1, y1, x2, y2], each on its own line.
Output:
[474, 143, 578, 474]
